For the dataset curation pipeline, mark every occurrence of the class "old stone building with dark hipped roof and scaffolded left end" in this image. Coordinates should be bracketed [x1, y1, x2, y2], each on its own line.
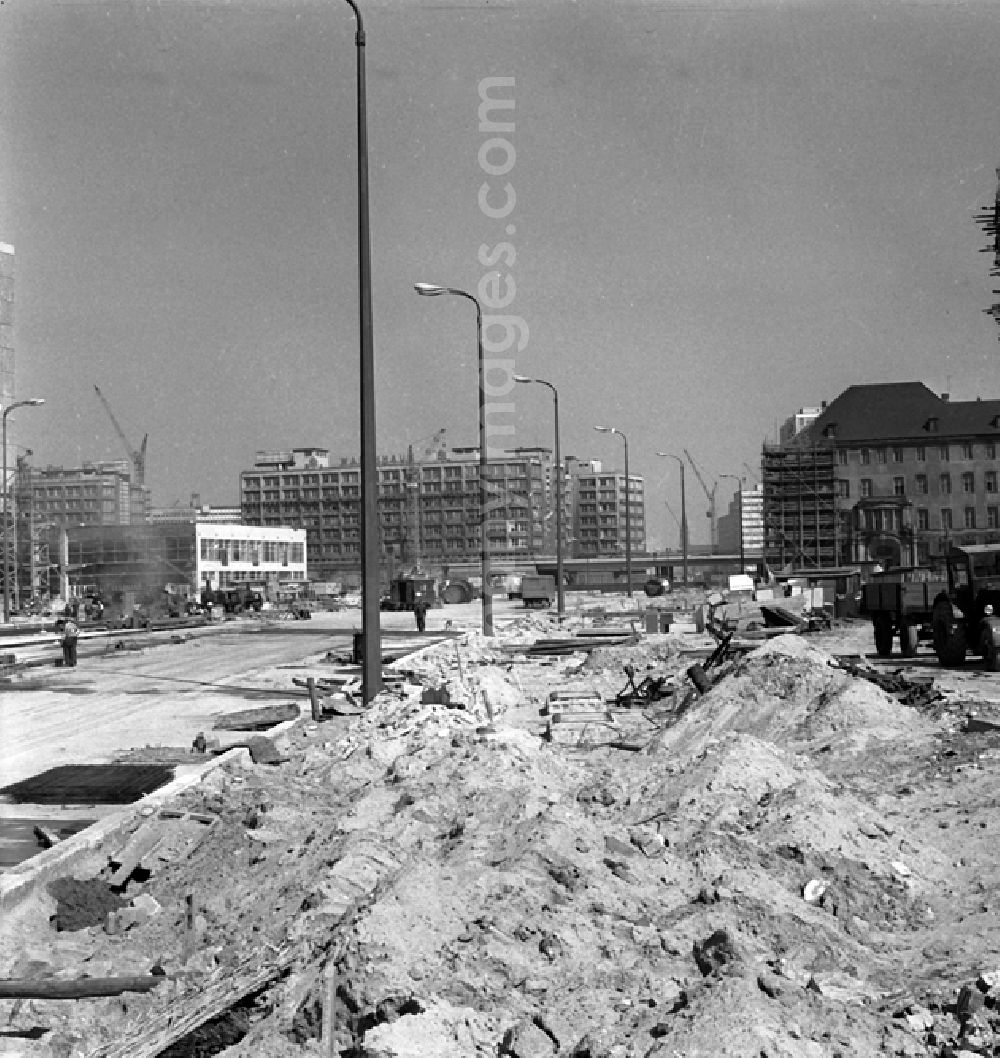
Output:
[763, 382, 1000, 567]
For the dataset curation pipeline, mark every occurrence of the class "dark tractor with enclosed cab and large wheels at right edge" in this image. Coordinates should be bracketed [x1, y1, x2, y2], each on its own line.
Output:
[931, 544, 1000, 672]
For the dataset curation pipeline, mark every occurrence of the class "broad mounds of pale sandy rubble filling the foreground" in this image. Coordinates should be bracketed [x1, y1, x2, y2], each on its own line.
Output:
[0, 628, 1000, 1058]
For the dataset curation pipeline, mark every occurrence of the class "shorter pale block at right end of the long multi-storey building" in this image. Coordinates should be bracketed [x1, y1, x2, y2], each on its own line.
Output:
[568, 460, 646, 559]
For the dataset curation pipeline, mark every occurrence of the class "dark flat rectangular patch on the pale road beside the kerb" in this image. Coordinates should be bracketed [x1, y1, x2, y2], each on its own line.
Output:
[0, 764, 174, 804]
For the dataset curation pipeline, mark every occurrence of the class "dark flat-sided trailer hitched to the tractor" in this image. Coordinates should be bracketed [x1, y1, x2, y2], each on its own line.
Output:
[860, 566, 948, 658]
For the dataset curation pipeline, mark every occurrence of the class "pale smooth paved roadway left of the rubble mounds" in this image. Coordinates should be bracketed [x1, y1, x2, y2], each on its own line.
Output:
[0, 614, 457, 786]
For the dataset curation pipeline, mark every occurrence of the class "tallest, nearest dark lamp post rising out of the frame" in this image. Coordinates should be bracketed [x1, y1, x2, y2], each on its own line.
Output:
[336, 0, 382, 701]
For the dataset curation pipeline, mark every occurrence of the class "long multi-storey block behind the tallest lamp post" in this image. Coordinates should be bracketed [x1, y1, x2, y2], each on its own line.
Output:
[240, 448, 551, 580]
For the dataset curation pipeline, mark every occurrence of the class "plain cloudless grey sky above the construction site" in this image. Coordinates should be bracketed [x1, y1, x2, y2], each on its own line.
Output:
[0, 0, 1000, 547]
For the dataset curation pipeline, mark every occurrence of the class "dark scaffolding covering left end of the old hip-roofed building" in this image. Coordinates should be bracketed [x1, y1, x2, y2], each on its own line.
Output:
[761, 444, 844, 569]
